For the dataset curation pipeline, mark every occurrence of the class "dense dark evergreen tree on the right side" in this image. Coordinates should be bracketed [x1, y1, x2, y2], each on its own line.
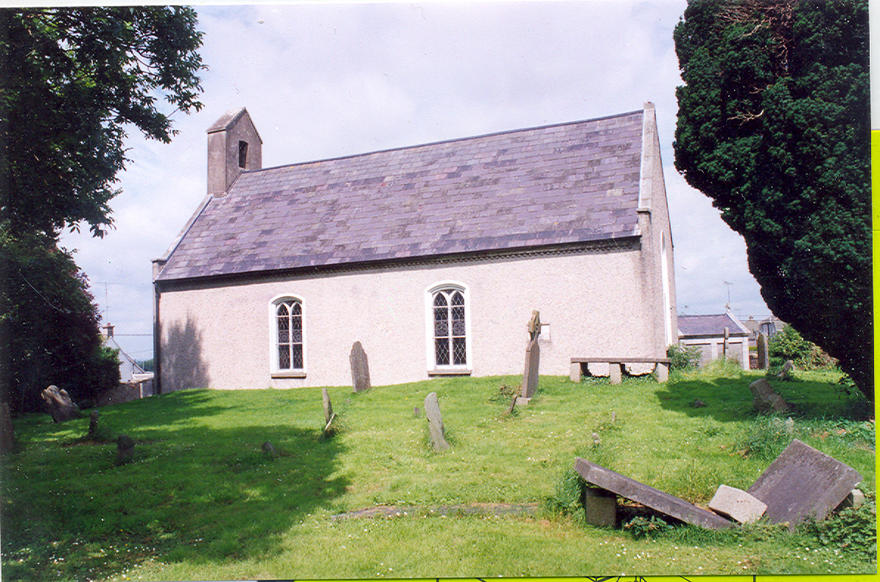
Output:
[674, 0, 874, 400]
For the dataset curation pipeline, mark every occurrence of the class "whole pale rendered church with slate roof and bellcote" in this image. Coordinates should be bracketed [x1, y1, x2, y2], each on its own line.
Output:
[153, 103, 679, 392]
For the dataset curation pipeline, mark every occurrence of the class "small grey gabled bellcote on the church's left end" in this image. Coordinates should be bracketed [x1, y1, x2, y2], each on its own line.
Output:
[208, 107, 263, 197]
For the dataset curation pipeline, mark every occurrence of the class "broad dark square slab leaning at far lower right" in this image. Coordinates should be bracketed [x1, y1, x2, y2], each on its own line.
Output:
[749, 439, 862, 529]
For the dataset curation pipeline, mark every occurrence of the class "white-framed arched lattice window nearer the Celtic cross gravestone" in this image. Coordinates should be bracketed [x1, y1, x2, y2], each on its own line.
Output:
[431, 287, 468, 369]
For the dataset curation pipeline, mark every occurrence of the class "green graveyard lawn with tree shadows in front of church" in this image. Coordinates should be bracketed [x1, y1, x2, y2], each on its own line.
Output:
[0, 370, 876, 580]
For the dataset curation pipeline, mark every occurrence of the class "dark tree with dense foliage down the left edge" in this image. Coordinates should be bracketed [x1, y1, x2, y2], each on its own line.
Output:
[0, 6, 203, 410]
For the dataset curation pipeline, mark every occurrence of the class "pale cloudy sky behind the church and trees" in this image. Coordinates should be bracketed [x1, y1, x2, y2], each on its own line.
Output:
[62, 0, 769, 359]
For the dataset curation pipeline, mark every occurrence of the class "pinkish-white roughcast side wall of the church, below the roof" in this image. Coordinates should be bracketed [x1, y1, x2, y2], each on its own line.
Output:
[160, 249, 671, 392]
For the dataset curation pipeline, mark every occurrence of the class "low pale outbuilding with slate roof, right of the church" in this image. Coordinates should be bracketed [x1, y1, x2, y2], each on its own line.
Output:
[678, 311, 751, 370]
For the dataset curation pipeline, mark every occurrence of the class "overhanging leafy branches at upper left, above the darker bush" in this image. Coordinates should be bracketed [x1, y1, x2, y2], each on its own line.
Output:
[0, 6, 203, 236]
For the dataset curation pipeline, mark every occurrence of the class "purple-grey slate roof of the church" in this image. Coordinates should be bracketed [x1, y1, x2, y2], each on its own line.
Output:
[158, 110, 643, 280]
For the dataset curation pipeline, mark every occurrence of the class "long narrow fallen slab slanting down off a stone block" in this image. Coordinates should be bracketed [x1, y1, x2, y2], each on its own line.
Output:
[574, 457, 733, 529]
